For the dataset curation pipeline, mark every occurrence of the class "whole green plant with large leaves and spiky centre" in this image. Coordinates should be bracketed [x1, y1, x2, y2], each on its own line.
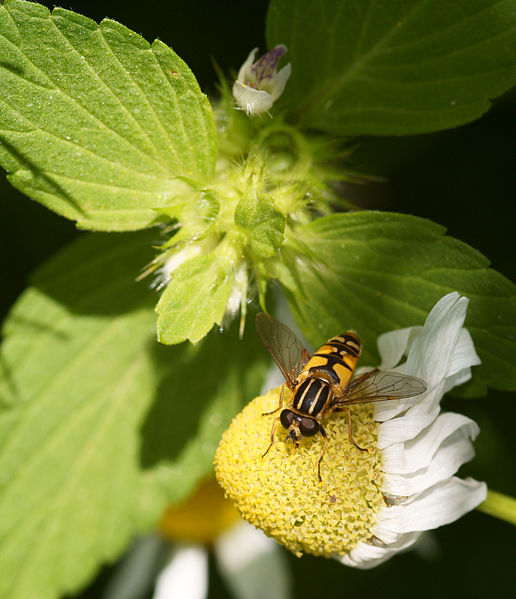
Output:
[0, 0, 516, 599]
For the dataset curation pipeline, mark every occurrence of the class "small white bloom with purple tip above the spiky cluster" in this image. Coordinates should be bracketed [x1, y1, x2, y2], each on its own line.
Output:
[233, 45, 292, 116]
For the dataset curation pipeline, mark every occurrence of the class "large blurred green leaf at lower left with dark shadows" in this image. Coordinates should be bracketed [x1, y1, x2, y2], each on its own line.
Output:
[0, 232, 267, 599]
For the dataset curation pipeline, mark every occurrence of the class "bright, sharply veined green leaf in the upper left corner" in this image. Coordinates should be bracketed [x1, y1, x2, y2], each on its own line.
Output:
[0, 0, 216, 231]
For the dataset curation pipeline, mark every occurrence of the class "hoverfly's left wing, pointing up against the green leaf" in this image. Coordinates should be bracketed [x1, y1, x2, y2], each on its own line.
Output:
[256, 312, 310, 385]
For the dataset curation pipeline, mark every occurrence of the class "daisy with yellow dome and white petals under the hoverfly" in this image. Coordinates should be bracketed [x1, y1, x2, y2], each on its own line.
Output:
[215, 293, 487, 568]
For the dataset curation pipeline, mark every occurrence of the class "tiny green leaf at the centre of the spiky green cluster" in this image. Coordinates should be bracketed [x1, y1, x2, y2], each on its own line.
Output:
[235, 191, 285, 259]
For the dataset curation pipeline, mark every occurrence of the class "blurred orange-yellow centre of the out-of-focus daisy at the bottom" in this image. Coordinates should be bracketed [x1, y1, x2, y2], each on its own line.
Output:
[158, 479, 239, 544]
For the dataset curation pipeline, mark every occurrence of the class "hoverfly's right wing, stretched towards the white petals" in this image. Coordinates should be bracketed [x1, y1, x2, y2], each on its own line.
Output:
[334, 370, 428, 406]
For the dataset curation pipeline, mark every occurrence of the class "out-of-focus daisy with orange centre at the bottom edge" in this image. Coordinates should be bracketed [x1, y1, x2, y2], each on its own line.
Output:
[103, 479, 291, 599]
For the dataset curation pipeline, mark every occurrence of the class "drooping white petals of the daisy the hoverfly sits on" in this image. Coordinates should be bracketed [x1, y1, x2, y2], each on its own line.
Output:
[338, 293, 487, 568]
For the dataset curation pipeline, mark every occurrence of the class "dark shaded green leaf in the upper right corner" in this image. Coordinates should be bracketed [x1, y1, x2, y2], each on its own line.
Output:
[267, 0, 516, 135]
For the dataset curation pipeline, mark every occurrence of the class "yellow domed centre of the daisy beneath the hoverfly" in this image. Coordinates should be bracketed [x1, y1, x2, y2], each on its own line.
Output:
[215, 387, 385, 557]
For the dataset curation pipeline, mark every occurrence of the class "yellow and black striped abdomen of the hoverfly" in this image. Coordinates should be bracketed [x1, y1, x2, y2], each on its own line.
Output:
[303, 331, 362, 389]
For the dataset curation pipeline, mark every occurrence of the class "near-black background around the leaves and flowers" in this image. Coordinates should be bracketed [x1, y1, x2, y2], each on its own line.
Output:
[0, 0, 516, 599]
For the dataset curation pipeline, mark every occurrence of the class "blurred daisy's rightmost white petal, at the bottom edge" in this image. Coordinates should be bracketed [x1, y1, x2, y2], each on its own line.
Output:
[215, 522, 291, 599]
